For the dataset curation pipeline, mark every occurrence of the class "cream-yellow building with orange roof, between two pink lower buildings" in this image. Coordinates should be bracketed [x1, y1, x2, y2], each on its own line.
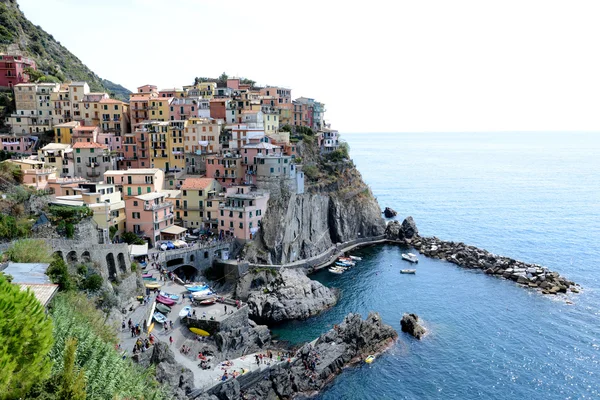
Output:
[178, 178, 221, 230]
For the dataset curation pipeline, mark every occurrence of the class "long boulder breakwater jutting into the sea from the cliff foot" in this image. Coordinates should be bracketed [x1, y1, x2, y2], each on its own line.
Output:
[386, 217, 579, 294]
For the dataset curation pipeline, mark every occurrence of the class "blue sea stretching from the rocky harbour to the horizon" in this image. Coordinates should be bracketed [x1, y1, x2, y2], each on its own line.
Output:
[273, 132, 600, 400]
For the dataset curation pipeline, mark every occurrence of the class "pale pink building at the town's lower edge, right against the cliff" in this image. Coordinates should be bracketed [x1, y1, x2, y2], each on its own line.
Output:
[218, 186, 269, 241]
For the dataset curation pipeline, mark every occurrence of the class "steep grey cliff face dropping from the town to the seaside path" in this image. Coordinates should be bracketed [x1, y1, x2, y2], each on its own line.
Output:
[243, 141, 385, 264]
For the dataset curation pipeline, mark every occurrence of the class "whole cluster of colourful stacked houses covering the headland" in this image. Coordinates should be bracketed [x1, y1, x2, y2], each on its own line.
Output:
[0, 55, 340, 249]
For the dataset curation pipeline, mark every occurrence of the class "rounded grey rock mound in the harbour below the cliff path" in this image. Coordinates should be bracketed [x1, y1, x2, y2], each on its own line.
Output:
[236, 268, 337, 323]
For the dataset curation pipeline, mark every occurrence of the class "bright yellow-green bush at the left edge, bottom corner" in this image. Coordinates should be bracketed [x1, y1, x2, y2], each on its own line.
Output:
[0, 274, 52, 399]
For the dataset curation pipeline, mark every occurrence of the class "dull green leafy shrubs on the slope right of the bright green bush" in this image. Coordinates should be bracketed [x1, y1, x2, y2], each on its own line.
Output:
[44, 293, 166, 400]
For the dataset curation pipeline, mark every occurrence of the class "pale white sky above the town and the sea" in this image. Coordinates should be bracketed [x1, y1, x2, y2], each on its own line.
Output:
[19, 0, 600, 132]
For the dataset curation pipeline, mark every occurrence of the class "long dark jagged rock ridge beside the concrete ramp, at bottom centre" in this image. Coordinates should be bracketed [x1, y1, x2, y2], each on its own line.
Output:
[198, 313, 398, 400]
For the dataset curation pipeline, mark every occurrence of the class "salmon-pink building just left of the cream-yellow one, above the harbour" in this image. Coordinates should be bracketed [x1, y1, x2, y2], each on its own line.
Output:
[125, 193, 176, 246]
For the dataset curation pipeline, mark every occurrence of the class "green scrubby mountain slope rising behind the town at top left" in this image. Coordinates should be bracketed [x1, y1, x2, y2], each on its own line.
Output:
[0, 0, 130, 99]
